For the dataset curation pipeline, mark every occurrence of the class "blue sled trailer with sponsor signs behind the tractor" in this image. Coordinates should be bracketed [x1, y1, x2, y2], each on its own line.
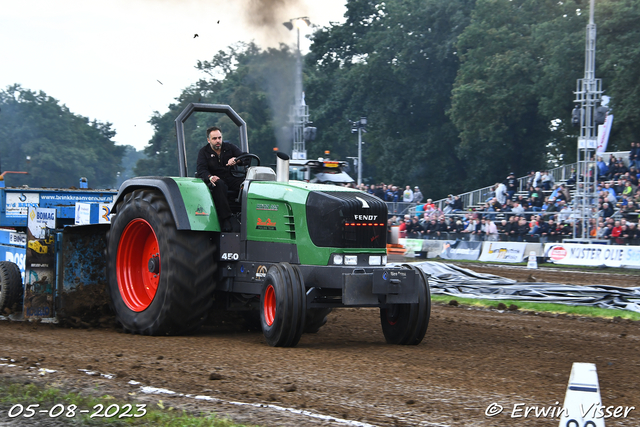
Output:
[0, 181, 117, 322]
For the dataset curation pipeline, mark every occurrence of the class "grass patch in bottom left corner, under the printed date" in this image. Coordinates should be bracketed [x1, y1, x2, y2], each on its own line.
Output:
[0, 378, 258, 427]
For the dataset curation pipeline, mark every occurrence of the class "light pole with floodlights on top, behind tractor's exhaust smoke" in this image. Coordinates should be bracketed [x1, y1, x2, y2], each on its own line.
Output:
[282, 16, 311, 160]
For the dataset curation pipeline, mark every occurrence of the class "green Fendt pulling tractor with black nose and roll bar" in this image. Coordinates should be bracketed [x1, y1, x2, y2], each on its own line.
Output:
[107, 104, 431, 347]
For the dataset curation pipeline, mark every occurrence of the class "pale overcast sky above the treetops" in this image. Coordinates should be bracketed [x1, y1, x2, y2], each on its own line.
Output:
[0, 0, 346, 149]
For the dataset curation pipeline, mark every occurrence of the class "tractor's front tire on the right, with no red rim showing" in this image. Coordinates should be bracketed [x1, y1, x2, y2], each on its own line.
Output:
[380, 265, 431, 345]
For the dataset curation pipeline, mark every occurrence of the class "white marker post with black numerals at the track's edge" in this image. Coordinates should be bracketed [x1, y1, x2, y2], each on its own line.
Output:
[559, 362, 605, 427]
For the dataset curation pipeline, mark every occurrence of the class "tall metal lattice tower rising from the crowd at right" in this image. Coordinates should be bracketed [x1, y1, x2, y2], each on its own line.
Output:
[573, 0, 602, 241]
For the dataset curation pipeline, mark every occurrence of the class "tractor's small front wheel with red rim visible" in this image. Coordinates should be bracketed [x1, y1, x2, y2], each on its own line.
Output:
[260, 262, 307, 347]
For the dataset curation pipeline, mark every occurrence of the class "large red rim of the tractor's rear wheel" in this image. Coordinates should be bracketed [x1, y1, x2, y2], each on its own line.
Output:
[116, 218, 160, 311]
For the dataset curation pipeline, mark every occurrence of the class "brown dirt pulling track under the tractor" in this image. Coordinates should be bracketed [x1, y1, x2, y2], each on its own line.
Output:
[0, 267, 640, 426]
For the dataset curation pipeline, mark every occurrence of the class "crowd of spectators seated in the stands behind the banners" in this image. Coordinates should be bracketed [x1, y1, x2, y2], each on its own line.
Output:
[359, 149, 640, 244]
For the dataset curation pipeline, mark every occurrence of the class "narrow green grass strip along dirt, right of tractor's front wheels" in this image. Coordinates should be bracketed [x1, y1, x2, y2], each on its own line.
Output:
[431, 295, 640, 320]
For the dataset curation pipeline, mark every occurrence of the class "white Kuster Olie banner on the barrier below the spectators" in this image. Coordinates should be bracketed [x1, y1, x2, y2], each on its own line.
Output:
[544, 243, 640, 268]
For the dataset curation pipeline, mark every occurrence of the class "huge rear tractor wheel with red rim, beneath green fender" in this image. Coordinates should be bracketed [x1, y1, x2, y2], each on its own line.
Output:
[107, 189, 217, 335]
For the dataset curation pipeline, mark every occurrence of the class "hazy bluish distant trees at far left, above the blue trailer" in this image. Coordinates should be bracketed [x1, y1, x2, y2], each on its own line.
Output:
[0, 84, 126, 188]
